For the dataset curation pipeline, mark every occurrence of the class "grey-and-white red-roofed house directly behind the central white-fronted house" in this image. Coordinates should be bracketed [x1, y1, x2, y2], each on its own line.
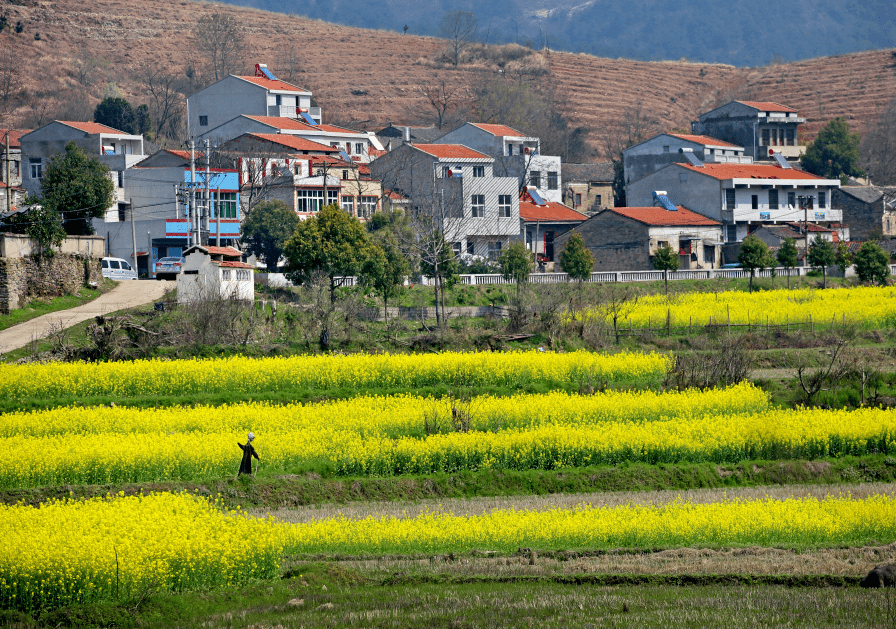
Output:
[435, 122, 563, 203]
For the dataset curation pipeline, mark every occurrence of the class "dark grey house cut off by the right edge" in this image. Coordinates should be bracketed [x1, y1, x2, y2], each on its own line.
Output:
[831, 186, 896, 240]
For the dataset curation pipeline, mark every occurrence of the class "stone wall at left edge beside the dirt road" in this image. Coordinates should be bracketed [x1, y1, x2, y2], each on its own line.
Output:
[0, 234, 103, 314]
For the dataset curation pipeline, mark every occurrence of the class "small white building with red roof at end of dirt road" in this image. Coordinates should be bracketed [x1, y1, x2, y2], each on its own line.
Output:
[177, 245, 255, 304]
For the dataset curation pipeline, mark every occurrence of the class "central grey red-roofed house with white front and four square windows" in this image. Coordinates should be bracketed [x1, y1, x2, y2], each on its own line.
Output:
[370, 144, 520, 258]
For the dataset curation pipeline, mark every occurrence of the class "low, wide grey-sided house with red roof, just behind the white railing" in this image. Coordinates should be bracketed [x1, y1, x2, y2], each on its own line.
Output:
[554, 202, 722, 271]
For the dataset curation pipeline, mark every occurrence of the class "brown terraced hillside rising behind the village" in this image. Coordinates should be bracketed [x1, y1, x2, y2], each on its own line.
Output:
[0, 0, 896, 147]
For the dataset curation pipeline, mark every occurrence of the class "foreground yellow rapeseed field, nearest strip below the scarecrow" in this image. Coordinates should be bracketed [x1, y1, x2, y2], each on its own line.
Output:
[0, 494, 896, 609]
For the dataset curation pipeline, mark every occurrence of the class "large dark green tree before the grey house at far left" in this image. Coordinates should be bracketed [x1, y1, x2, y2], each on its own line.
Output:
[38, 142, 115, 235]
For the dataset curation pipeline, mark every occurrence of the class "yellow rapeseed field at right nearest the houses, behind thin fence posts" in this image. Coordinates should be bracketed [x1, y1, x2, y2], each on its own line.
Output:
[591, 286, 896, 328]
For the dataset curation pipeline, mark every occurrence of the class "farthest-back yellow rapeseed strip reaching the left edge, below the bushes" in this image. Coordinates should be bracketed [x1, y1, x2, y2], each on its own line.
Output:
[0, 352, 669, 400]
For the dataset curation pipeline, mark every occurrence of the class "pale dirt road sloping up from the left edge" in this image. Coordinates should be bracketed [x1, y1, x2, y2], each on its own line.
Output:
[0, 280, 175, 354]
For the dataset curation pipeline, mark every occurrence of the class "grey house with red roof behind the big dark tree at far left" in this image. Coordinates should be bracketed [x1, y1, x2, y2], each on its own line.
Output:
[19, 120, 146, 222]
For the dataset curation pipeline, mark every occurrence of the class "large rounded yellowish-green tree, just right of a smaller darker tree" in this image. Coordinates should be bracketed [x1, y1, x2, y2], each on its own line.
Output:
[283, 205, 370, 303]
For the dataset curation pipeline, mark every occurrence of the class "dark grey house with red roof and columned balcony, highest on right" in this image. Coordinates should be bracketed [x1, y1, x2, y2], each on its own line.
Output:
[691, 100, 806, 161]
